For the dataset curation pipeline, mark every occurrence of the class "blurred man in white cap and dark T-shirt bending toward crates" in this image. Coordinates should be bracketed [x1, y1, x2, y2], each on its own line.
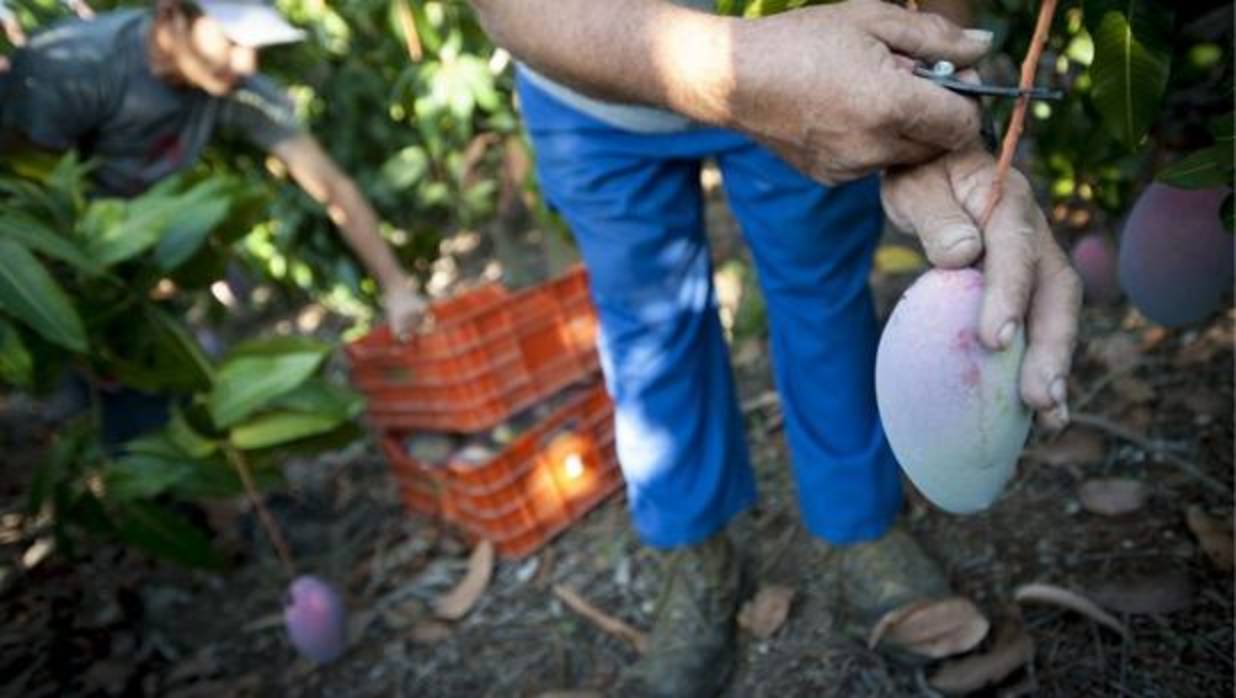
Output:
[0, 0, 424, 334]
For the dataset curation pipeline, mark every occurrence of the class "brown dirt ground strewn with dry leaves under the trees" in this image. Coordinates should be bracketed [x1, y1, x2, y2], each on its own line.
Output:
[0, 182, 1234, 698]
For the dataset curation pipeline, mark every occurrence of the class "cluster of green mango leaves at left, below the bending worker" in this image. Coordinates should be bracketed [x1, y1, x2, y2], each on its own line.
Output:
[0, 154, 362, 566]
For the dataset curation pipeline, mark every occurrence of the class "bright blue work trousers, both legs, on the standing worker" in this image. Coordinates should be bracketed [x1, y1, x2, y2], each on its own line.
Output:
[518, 72, 901, 549]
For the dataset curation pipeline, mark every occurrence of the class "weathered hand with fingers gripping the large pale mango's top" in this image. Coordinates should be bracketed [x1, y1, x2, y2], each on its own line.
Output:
[883, 145, 1082, 427]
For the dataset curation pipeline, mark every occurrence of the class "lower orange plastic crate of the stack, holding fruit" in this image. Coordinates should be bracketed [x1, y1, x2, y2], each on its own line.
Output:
[381, 381, 623, 557]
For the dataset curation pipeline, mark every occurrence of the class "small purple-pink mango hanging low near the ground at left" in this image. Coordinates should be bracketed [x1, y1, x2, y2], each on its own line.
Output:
[283, 574, 347, 663]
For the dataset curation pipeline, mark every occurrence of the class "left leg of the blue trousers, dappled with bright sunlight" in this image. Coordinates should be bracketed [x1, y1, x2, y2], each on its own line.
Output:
[519, 72, 755, 547]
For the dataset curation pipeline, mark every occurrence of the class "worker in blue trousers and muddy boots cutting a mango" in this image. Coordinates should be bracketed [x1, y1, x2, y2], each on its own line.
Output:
[472, 0, 1080, 697]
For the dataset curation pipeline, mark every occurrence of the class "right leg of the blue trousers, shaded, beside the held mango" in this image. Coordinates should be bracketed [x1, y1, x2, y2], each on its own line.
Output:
[718, 142, 901, 544]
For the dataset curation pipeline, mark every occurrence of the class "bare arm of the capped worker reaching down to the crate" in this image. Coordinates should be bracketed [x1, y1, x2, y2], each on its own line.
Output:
[271, 133, 425, 336]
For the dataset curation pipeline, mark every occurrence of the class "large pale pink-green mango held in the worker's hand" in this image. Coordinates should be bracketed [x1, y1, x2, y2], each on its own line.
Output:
[875, 269, 1031, 514]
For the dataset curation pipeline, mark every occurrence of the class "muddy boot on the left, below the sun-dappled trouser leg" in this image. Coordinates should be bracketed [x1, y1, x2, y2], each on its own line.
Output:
[632, 532, 747, 698]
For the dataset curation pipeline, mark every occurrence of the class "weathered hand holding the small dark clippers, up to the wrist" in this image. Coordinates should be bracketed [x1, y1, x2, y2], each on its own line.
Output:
[728, 0, 991, 184]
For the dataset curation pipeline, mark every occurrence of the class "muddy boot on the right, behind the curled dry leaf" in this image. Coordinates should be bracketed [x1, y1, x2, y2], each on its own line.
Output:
[833, 528, 952, 663]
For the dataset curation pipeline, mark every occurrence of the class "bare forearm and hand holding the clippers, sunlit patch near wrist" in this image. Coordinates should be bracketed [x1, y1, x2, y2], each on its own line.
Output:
[471, 0, 990, 183]
